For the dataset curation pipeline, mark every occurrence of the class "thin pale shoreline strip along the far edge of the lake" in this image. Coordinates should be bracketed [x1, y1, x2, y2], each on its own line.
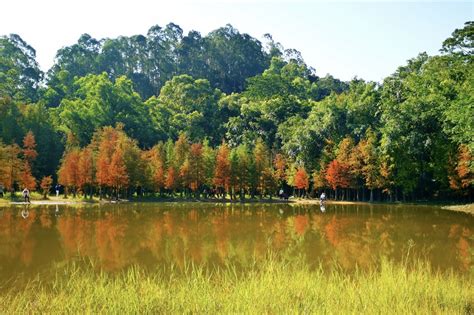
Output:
[0, 197, 474, 215]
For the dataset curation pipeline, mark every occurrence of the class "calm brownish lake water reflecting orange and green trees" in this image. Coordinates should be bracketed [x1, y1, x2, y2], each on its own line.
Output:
[0, 203, 474, 281]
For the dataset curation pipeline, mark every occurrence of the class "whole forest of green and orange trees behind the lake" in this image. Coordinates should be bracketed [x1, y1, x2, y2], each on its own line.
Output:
[0, 21, 474, 201]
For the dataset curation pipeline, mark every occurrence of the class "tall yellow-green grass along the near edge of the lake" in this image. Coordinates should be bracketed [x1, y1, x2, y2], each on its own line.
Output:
[0, 259, 474, 314]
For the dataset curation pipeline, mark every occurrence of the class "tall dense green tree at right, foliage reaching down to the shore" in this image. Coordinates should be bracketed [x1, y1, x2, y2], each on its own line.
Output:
[381, 54, 450, 195]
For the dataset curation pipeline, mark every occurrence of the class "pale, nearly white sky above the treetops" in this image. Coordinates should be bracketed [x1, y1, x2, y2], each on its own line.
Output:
[0, 0, 474, 81]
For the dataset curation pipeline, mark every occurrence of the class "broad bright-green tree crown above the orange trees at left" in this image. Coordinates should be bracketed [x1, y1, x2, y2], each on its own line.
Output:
[52, 73, 155, 145]
